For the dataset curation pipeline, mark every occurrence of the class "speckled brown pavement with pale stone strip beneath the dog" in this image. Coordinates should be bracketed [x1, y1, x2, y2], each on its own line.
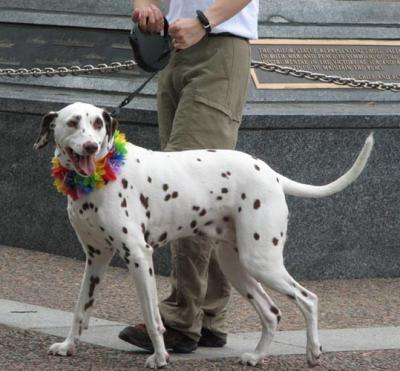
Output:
[0, 246, 400, 370]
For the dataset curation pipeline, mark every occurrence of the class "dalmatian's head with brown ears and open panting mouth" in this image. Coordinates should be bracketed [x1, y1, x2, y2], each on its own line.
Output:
[34, 103, 118, 176]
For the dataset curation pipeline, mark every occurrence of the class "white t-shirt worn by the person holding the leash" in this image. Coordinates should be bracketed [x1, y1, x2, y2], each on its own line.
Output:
[165, 0, 259, 39]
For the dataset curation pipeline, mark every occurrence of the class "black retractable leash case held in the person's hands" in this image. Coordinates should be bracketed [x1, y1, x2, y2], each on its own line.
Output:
[129, 18, 172, 72]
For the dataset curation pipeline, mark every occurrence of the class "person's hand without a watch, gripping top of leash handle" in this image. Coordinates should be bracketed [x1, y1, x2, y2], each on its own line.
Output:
[132, 0, 164, 33]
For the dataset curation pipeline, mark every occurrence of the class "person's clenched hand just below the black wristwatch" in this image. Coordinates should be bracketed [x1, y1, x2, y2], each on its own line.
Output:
[169, 18, 206, 49]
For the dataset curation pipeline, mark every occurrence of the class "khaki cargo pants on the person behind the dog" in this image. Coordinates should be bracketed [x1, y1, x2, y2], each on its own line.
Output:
[157, 36, 250, 340]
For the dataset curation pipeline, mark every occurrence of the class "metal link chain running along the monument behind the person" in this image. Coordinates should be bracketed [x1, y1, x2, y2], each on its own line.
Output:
[0, 60, 400, 93]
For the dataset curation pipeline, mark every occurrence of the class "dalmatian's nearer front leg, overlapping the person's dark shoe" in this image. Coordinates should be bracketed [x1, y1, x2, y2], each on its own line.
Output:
[124, 240, 169, 368]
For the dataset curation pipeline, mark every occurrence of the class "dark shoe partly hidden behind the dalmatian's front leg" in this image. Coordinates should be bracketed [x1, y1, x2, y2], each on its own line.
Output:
[118, 324, 197, 353]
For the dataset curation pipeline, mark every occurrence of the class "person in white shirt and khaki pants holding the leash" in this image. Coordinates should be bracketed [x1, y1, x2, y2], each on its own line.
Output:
[119, 0, 259, 353]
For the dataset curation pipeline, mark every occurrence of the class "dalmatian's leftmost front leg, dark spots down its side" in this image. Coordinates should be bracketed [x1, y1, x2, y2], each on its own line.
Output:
[48, 244, 114, 356]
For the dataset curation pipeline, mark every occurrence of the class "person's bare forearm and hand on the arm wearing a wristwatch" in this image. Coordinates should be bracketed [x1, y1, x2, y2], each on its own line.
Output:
[169, 0, 251, 49]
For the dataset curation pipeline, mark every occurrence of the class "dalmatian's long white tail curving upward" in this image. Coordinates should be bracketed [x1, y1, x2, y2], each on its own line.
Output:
[279, 133, 374, 198]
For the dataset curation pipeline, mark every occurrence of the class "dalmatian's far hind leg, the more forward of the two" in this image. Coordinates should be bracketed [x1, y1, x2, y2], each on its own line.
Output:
[217, 243, 281, 366]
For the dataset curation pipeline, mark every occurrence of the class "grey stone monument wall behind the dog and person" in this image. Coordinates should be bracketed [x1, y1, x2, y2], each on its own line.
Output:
[0, 0, 400, 279]
